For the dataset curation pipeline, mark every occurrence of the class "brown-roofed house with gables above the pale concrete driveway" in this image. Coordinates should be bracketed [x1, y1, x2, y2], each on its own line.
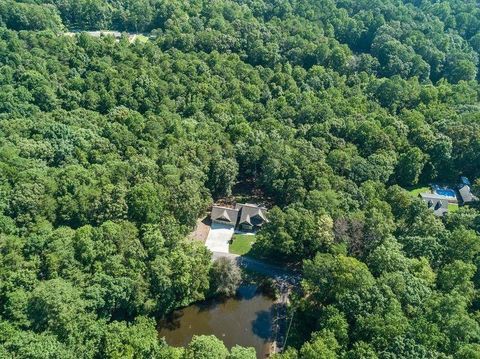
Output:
[210, 203, 268, 231]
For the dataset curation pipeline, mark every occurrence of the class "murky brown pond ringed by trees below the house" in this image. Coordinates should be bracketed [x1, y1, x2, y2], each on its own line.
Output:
[159, 285, 274, 358]
